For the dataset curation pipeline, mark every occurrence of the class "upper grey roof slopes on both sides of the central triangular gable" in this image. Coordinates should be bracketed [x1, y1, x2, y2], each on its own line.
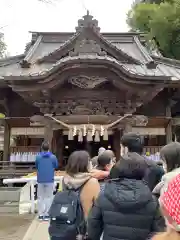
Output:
[26, 32, 147, 62]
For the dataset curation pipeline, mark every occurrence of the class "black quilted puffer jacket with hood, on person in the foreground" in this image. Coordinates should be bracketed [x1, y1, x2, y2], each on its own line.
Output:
[88, 178, 164, 240]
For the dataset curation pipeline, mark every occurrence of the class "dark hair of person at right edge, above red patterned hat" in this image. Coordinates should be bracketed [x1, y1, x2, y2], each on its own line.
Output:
[160, 142, 180, 172]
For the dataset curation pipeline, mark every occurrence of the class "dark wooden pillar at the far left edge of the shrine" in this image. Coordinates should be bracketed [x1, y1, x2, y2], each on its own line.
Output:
[3, 120, 11, 164]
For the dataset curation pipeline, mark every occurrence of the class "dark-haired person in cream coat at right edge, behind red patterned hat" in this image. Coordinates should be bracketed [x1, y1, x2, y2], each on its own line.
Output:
[153, 142, 180, 195]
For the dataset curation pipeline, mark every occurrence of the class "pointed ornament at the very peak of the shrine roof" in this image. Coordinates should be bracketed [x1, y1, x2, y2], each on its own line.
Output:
[76, 10, 100, 32]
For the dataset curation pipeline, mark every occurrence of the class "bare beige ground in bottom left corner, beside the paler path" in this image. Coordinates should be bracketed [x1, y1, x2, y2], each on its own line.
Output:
[0, 214, 34, 240]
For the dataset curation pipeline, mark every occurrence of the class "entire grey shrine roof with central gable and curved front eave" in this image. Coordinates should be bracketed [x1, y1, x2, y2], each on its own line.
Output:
[0, 14, 180, 81]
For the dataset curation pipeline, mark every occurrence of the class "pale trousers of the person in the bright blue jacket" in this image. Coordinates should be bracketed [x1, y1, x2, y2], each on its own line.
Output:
[37, 183, 54, 217]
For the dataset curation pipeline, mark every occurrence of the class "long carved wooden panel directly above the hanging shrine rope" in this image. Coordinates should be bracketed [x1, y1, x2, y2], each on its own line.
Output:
[35, 99, 139, 116]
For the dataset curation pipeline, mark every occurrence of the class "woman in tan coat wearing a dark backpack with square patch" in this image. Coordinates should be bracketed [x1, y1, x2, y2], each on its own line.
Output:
[49, 151, 100, 240]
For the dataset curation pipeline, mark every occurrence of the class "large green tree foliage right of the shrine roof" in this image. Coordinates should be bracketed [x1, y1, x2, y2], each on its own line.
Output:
[127, 0, 180, 60]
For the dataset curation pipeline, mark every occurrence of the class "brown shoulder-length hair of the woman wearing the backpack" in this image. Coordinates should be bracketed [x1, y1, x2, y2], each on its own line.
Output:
[66, 151, 90, 175]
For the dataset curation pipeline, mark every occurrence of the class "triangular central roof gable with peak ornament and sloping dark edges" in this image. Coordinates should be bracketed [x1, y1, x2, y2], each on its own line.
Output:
[34, 12, 141, 64]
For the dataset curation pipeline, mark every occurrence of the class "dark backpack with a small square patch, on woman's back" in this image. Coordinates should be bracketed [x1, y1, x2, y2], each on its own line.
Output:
[49, 182, 86, 240]
